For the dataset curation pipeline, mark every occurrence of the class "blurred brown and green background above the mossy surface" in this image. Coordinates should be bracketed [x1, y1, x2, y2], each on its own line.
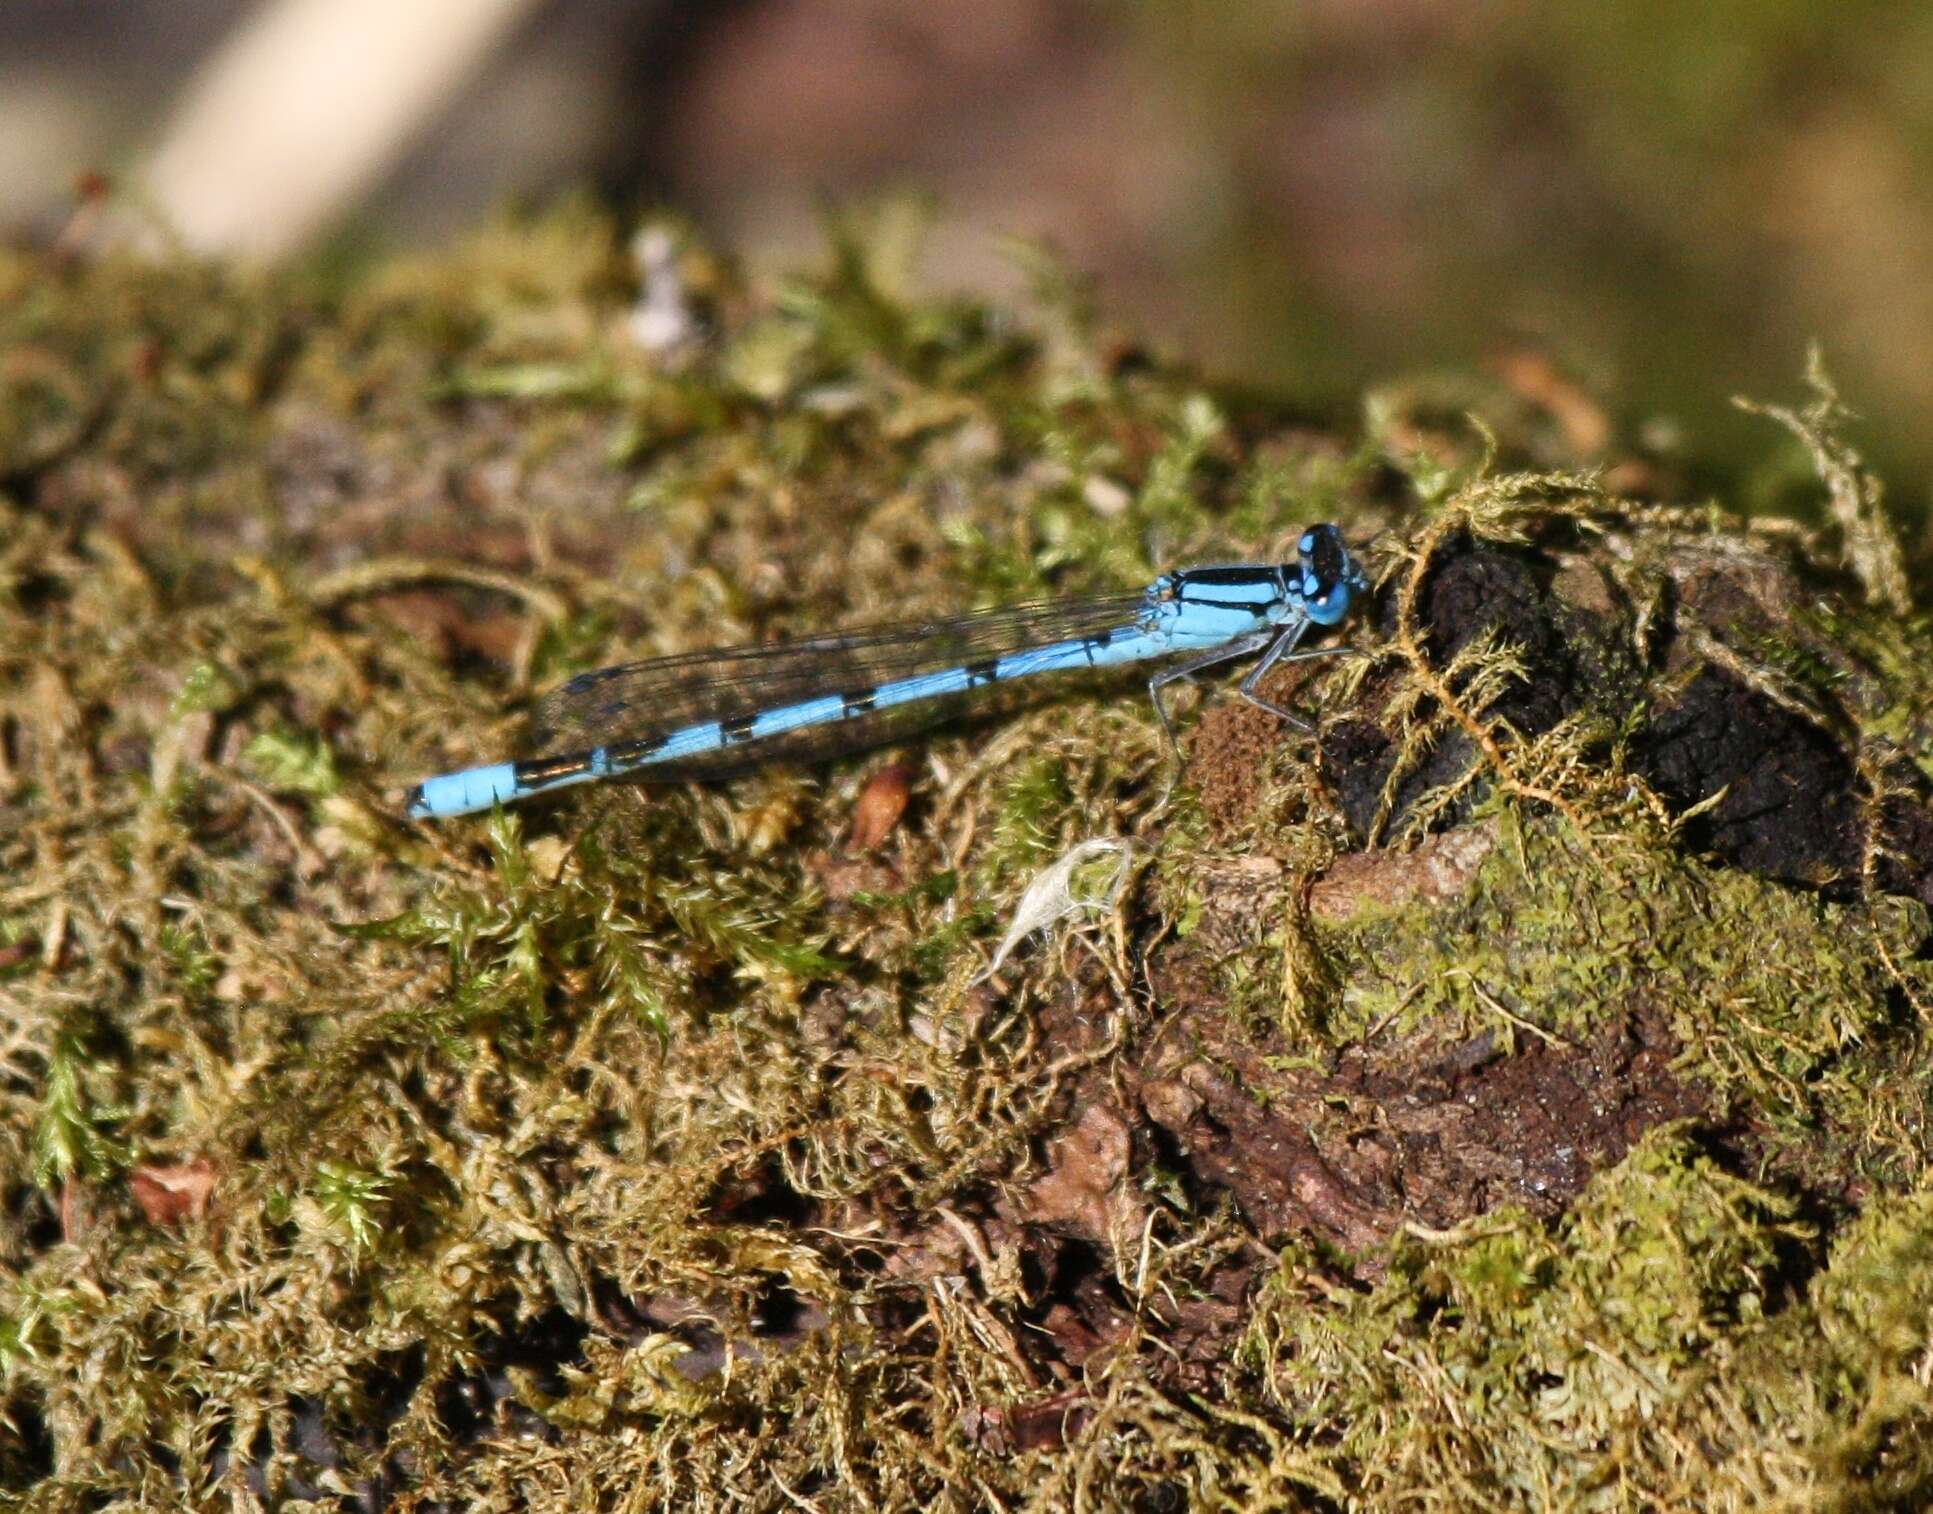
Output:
[0, 0, 1933, 509]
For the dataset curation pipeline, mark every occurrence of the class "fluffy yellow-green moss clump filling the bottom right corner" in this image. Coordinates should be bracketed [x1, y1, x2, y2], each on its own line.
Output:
[1247, 1127, 1933, 1508]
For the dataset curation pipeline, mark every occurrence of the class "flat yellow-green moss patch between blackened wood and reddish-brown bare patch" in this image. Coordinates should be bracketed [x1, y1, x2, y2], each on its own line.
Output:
[1324, 826, 1927, 1135]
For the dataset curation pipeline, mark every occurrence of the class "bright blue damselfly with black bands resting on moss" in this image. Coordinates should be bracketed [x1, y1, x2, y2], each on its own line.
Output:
[408, 526, 1369, 820]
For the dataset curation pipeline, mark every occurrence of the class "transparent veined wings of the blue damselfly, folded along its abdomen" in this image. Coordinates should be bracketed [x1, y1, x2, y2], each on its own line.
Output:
[534, 594, 1146, 779]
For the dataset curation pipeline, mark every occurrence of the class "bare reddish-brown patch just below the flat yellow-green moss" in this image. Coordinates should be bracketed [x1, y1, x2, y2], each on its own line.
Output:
[1139, 1007, 1707, 1276]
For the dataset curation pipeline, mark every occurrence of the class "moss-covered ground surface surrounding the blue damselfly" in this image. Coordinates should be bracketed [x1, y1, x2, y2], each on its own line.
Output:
[0, 209, 1933, 1510]
